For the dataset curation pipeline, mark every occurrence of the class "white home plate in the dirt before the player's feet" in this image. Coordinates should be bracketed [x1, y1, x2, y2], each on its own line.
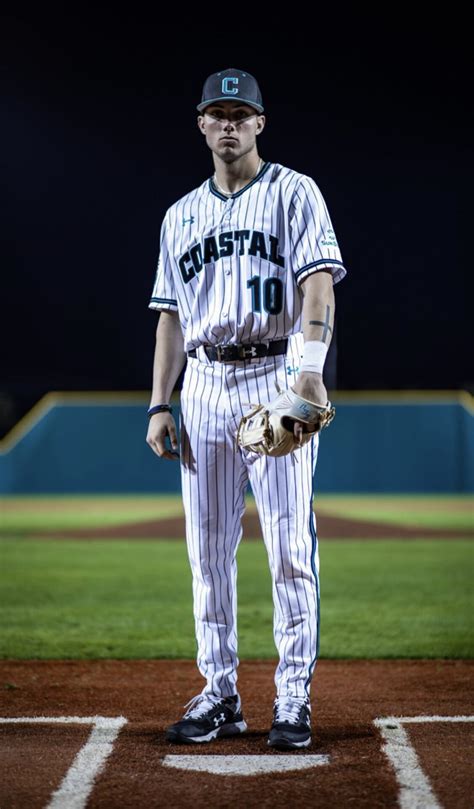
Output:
[162, 755, 330, 775]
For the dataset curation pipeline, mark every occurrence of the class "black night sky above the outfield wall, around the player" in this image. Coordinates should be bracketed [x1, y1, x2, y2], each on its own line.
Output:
[0, 11, 474, 434]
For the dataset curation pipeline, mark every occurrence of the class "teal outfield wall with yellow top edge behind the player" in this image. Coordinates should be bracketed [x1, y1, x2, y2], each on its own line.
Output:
[0, 392, 474, 494]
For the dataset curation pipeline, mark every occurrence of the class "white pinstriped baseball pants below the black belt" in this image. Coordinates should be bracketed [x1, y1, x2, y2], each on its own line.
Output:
[180, 334, 319, 696]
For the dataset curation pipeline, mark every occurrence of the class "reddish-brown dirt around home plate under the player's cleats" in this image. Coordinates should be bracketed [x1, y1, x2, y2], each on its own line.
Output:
[0, 660, 474, 809]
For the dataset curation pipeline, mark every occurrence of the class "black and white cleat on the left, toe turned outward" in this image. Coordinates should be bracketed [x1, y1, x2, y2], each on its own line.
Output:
[165, 694, 247, 744]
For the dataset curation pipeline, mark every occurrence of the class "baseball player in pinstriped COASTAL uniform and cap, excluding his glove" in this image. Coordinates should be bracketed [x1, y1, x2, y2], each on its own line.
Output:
[146, 68, 346, 750]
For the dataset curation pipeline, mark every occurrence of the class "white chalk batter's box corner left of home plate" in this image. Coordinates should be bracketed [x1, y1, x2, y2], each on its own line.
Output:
[0, 716, 127, 809]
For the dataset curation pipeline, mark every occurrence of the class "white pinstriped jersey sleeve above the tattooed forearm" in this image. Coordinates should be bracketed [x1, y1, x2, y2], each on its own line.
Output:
[290, 176, 347, 286]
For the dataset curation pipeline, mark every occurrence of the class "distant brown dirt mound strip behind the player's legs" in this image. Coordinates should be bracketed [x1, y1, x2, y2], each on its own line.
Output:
[27, 512, 474, 540]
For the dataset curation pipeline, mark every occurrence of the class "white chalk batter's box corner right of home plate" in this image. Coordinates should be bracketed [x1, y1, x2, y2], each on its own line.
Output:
[374, 715, 474, 809]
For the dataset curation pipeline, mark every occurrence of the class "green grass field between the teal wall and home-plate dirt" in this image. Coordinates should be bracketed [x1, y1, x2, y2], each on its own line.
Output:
[0, 497, 474, 659]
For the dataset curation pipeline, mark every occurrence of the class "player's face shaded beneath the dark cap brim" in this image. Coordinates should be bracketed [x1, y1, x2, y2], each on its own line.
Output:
[198, 101, 265, 163]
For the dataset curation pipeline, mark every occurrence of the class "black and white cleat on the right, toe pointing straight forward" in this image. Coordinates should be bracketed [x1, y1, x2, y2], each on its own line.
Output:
[268, 697, 311, 750]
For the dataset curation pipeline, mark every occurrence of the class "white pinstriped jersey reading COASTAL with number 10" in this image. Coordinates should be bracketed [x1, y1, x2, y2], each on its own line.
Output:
[149, 162, 346, 351]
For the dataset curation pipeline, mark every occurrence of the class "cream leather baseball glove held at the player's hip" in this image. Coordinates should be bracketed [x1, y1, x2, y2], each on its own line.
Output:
[236, 386, 336, 458]
